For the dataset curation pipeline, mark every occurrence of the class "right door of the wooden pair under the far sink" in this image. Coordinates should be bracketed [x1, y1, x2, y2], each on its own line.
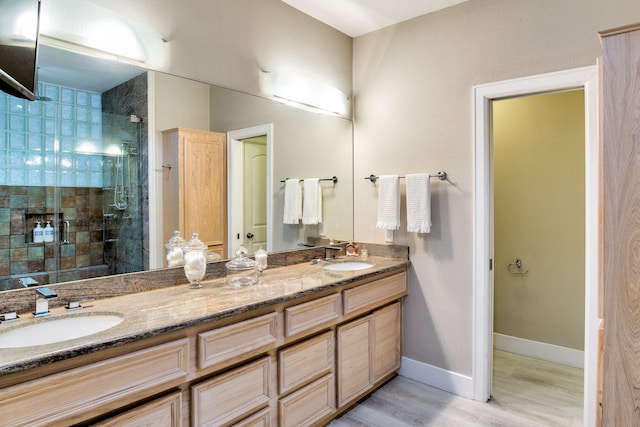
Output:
[372, 303, 402, 382]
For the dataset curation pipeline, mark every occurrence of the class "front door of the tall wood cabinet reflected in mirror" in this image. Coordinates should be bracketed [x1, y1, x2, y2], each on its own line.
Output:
[180, 131, 227, 252]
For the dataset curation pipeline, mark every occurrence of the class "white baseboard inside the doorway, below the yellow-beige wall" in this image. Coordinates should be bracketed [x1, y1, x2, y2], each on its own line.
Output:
[493, 332, 584, 369]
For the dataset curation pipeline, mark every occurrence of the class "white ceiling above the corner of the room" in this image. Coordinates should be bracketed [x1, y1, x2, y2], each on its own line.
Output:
[282, 0, 468, 37]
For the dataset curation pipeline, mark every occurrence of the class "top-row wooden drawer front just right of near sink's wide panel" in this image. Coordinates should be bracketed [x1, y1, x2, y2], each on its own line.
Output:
[198, 313, 278, 369]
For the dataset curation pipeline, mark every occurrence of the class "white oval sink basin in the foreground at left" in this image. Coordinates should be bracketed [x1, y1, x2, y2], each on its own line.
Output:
[0, 314, 124, 348]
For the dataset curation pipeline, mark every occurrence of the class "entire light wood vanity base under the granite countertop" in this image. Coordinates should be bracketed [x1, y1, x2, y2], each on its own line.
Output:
[0, 270, 406, 427]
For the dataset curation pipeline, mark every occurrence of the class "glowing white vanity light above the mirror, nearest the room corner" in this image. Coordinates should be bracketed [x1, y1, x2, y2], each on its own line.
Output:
[261, 71, 349, 115]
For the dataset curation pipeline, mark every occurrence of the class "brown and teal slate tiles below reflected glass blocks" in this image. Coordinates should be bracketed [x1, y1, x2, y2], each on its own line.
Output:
[0, 185, 107, 290]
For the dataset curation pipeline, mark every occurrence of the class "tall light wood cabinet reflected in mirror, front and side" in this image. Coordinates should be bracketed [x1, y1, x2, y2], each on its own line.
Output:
[162, 128, 227, 258]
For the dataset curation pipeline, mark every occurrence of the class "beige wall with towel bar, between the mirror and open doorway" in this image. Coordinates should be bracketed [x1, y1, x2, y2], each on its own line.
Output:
[353, 0, 640, 376]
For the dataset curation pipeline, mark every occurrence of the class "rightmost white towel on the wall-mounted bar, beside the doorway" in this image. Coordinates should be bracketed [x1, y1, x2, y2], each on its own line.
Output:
[406, 173, 431, 233]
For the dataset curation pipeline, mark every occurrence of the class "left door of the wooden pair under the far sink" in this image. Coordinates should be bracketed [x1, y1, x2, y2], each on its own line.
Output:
[337, 316, 374, 406]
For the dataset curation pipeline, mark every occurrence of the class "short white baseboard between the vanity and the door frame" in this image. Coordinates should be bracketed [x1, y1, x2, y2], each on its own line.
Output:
[398, 357, 474, 399]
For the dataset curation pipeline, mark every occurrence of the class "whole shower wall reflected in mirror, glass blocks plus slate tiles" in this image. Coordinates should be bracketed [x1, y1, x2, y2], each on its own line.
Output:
[0, 74, 148, 290]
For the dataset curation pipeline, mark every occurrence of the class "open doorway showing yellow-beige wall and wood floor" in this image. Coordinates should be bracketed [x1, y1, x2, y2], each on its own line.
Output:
[491, 89, 585, 425]
